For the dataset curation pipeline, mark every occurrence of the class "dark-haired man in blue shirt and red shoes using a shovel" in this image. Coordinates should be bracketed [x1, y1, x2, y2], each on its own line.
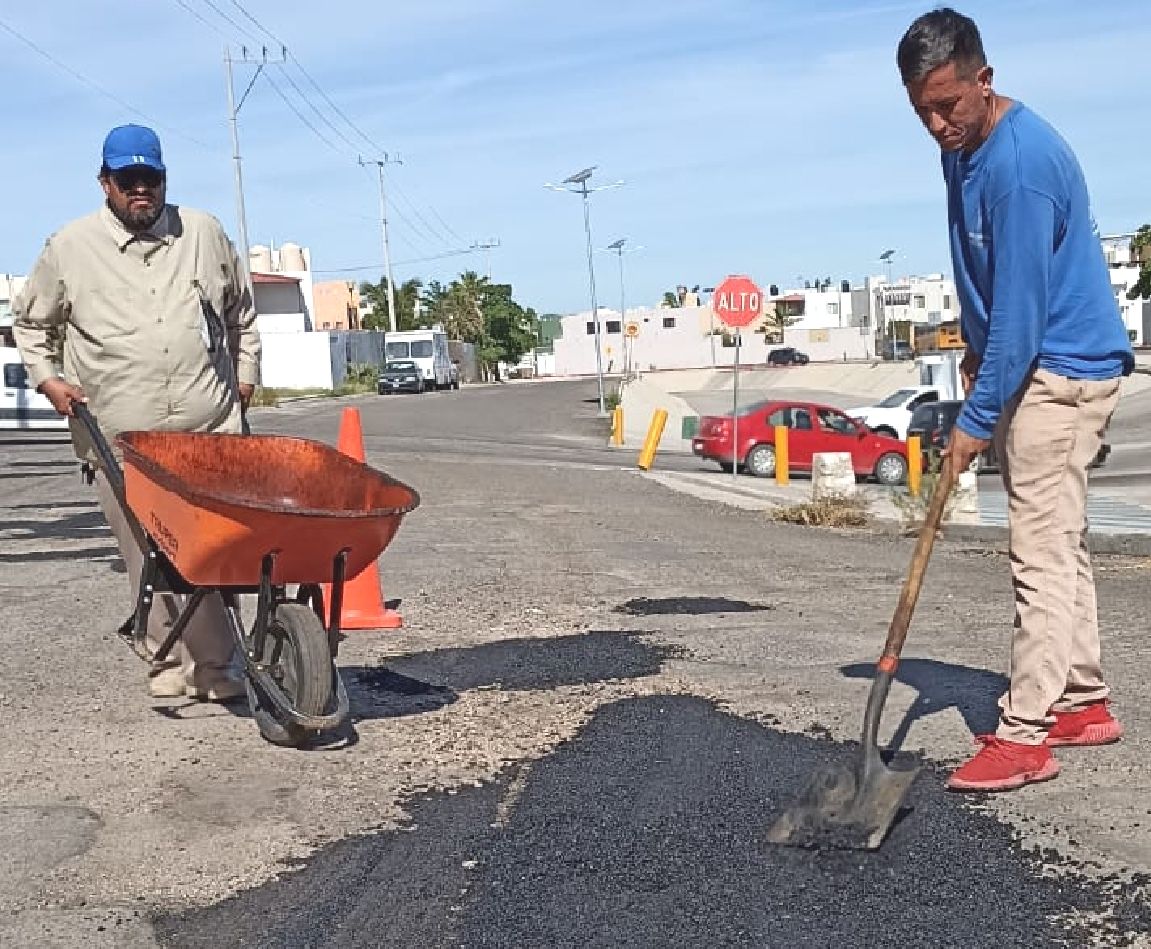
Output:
[897, 8, 1134, 790]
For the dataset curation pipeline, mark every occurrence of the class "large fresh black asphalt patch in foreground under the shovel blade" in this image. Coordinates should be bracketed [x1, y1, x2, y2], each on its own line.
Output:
[154, 696, 1151, 949]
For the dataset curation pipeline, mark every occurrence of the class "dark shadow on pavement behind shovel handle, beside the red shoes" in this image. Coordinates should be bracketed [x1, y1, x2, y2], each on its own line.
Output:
[839, 658, 1007, 750]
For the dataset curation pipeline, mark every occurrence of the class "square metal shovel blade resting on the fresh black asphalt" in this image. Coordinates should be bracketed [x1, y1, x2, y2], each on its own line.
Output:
[768, 764, 920, 850]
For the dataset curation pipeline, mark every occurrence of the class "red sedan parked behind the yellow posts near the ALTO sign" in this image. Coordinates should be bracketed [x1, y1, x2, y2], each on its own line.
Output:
[692, 401, 907, 484]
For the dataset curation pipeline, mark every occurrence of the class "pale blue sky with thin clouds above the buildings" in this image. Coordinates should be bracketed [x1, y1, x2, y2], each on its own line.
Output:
[0, 0, 1151, 312]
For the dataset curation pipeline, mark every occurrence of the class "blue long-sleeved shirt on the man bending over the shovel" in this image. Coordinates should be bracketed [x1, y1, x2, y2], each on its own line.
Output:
[943, 102, 1135, 438]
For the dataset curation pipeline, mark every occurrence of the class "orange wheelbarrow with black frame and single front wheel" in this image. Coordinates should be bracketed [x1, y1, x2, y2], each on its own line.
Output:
[73, 403, 419, 747]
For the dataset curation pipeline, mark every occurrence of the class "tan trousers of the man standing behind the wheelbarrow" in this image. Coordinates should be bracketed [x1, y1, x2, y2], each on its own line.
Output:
[93, 470, 235, 688]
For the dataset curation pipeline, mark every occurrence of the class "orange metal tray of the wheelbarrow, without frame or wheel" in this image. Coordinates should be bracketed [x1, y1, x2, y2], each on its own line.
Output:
[116, 431, 419, 587]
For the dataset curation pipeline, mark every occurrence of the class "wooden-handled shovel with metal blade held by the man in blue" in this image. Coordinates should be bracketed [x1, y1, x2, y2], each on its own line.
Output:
[768, 461, 955, 850]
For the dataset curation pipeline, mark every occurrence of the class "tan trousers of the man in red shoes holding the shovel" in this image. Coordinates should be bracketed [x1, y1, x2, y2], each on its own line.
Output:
[996, 369, 1120, 744]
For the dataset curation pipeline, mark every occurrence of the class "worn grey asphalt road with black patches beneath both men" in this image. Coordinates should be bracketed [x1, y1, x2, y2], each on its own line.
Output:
[0, 382, 1151, 949]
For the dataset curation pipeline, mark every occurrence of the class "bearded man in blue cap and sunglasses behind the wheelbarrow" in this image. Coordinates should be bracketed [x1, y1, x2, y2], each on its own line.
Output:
[13, 125, 260, 701]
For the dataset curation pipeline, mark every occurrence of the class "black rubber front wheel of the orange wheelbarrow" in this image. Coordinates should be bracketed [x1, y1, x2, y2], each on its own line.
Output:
[247, 603, 333, 748]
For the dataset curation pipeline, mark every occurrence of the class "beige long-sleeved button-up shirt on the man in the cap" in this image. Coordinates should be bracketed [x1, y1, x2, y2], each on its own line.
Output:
[13, 205, 260, 457]
